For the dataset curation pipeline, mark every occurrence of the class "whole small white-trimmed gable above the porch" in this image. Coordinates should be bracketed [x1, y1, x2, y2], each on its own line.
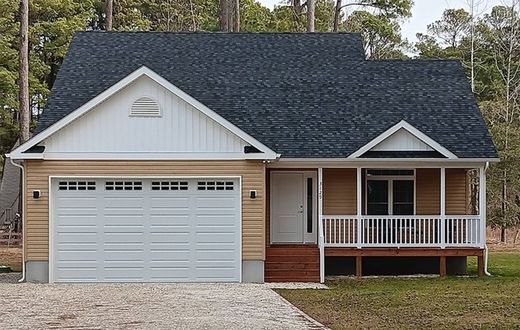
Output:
[348, 120, 458, 159]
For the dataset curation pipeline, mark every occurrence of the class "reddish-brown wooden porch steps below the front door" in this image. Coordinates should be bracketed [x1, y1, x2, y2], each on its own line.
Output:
[264, 245, 320, 282]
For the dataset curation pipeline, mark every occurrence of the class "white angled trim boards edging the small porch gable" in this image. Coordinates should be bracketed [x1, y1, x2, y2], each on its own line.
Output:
[348, 120, 458, 159]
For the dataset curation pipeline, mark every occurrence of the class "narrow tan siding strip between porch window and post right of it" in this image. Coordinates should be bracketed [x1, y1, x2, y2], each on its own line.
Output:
[415, 168, 441, 215]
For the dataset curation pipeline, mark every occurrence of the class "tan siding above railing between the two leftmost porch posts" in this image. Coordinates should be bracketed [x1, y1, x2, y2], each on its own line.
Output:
[323, 168, 357, 215]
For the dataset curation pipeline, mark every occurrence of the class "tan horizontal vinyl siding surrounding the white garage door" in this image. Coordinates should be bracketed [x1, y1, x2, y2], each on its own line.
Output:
[25, 160, 265, 260]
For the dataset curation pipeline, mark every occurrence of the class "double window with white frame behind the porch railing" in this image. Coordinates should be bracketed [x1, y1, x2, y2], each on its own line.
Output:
[365, 169, 415, 215]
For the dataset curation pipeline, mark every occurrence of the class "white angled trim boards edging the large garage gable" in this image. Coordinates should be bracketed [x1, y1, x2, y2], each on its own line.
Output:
[11, 66, 280, 159]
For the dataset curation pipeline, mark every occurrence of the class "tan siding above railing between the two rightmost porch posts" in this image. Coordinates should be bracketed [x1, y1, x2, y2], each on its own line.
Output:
[446, 168, 469, 215]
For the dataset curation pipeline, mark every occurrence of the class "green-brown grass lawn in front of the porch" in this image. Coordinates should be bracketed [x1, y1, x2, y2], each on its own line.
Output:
[276, 251, 520, 329]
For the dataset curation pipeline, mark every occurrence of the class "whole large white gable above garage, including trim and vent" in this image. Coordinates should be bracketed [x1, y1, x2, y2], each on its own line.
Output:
[12, 67, 276, 159]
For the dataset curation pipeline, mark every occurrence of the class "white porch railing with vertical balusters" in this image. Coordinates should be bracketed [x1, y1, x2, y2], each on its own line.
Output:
[320, 215, 484, 247]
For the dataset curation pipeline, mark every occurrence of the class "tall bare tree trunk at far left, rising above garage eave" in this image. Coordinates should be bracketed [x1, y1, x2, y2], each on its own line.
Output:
[18, 0, 31, 144]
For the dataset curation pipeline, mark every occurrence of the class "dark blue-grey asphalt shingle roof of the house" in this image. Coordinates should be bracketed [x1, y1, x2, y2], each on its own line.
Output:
[37, 32, 497, 158]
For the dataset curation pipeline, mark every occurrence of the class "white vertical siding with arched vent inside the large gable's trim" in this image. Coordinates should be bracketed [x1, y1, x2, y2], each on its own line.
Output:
[43, 75, 249, 159]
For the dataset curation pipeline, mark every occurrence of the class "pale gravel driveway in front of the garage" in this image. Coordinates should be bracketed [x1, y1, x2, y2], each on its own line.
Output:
[0, 278, 322, 329]
